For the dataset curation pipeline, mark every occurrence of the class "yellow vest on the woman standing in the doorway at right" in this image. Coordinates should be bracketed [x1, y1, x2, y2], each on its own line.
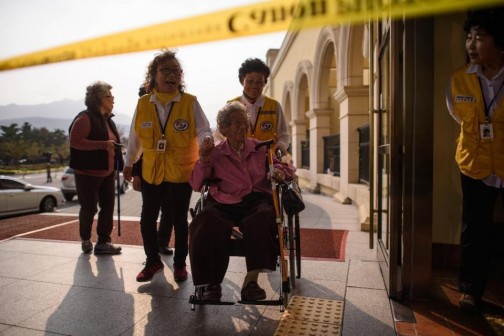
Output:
[451, 66, 504, 179]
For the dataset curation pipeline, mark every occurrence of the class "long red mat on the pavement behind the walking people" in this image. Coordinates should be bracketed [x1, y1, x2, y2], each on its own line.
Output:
[5, 215, 348, 261]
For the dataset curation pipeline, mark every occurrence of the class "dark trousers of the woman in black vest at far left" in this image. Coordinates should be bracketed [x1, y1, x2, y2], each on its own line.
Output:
[75, 173, 115, 243]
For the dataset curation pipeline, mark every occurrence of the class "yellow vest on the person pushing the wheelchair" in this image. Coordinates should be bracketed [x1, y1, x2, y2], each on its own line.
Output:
[230, 96, 278, 141]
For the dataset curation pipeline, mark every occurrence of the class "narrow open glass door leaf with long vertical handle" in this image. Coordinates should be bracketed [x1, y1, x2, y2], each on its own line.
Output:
[373, 21, 402, 297]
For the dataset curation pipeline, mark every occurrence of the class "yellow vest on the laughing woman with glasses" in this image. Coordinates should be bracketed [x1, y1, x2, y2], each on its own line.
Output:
[135, 93, 198, 185]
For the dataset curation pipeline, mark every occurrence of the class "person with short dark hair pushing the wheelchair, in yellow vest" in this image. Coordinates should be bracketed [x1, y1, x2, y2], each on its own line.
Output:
[228, 58, 290, 154]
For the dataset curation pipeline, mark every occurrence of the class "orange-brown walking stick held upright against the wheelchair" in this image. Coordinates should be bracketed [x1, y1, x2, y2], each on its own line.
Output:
[256, 139, 290, 306]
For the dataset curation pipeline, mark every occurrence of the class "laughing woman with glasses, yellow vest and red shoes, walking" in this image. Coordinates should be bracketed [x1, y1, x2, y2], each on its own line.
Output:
[123, 50, 213, 282]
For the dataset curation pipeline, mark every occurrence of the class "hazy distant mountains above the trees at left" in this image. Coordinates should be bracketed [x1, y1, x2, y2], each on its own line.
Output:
[0, 99, 131, 135]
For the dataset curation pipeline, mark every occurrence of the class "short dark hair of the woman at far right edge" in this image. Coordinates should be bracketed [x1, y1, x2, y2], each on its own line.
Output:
[464, 6, 504, 48]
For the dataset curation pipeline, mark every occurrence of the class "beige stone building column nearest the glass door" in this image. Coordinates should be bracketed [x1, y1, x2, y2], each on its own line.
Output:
[334, 85, 369, 203]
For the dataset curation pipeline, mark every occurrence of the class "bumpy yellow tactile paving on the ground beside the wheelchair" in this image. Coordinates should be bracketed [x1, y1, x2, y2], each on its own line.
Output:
[274, 296, 343, 336]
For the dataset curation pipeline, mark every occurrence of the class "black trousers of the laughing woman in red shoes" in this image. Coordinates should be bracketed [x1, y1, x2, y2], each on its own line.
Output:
[140, 180, 192, 267]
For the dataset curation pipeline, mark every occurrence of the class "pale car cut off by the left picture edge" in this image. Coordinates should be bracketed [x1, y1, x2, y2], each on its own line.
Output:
[0, 175, 64, 217]
